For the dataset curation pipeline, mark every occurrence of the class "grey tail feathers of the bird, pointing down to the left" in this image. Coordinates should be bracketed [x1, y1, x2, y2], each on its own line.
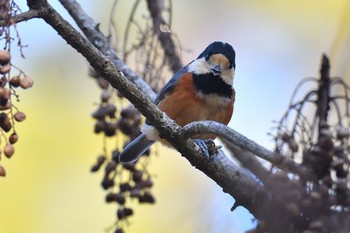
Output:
[119, 134, 154, 163]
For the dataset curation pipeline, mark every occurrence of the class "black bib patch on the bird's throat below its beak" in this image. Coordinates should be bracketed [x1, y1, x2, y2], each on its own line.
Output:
[192, 73, 233, 98]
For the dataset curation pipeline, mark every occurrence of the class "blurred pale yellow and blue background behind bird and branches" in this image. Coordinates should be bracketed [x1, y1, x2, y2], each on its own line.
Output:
[0, 0, 350, 233]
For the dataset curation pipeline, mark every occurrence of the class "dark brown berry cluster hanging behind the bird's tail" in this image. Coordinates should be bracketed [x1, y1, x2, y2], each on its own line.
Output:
[90, 71, 155, 233]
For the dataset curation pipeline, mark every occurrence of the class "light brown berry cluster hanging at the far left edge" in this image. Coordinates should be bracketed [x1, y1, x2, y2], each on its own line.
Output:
[0, 0, 33, 176]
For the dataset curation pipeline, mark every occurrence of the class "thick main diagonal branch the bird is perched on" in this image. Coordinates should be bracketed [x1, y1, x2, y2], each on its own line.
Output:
[29, 0, 274, 217]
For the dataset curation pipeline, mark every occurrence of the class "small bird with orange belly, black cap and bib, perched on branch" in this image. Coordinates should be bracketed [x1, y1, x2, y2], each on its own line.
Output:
[119, 41, 236, 162]
